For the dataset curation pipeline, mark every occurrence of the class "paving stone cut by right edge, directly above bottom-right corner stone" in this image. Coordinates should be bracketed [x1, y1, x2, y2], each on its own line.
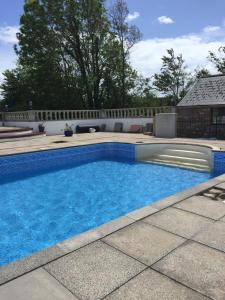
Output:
[193, 222, 225, 252]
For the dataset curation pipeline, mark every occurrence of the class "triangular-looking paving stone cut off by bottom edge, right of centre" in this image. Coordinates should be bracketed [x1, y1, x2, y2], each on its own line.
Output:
[105, 270, 209, 300]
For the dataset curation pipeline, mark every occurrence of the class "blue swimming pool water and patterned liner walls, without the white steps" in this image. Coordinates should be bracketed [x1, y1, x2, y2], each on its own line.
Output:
[0, 143, 212, 266]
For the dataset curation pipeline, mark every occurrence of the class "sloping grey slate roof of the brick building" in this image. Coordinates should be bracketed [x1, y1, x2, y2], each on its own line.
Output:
[177, 75, 225, 106]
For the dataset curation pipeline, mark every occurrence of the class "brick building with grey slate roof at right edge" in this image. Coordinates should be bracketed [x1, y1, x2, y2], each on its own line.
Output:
[177, 75, 225, 139]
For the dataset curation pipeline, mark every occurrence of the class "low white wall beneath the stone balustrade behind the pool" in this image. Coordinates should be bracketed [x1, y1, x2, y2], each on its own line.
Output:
[4, 118, 153, 135]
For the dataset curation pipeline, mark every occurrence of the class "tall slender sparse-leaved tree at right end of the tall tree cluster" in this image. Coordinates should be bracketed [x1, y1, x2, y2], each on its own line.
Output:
[110, 0, 141, 106]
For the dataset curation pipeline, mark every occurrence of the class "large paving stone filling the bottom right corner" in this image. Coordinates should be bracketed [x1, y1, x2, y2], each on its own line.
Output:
[153, 242, 225, 300]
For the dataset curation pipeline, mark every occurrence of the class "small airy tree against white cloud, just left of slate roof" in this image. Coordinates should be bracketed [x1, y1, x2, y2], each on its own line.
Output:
[153, 49, 190, 105]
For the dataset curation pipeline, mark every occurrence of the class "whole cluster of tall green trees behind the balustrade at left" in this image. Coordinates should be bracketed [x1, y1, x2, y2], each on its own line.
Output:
[1, 0, 157, 109]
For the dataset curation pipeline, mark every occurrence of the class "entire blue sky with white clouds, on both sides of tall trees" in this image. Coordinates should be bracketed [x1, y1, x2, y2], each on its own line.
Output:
[0, 0, 225, 80]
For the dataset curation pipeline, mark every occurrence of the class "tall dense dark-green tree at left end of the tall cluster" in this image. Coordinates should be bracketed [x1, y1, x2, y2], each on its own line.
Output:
[15, 0, 65, 109]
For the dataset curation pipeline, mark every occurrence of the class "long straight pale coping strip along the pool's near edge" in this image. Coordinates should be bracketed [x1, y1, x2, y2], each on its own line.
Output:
[0, 175, 225, 285]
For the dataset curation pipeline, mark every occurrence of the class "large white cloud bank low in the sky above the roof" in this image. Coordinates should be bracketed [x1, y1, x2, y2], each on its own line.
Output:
[131, 25, 225, 77]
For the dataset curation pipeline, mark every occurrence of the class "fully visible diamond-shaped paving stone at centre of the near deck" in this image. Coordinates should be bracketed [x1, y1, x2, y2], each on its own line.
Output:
[103, 222, 185, 265]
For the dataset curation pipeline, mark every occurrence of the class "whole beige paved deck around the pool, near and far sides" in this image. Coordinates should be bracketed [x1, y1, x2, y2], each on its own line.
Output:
[0, 133, 225, 300]
